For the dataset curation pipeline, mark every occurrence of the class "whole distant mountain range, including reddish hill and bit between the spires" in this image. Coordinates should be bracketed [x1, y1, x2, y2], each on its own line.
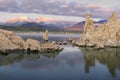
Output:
[0, 16, 106, 31]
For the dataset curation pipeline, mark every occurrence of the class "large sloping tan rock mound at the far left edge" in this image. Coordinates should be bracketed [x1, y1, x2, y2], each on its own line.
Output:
[0, 29, 24, 52]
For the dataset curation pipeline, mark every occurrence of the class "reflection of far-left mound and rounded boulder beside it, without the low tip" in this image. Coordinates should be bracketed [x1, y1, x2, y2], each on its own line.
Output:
[0, 54, 39, 66]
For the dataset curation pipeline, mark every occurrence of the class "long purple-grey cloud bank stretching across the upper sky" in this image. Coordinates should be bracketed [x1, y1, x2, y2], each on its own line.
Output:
[0, 0, 118, 18]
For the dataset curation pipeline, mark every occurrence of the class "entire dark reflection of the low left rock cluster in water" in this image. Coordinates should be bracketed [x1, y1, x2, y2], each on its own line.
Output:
[0, 51, 59, 66]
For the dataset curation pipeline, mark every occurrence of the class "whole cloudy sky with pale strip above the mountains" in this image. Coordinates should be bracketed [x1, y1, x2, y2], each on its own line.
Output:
[0, 0, 120, 21]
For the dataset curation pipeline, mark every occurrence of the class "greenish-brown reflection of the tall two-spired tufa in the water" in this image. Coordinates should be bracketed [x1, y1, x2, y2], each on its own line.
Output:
[80, 48, 120, 77]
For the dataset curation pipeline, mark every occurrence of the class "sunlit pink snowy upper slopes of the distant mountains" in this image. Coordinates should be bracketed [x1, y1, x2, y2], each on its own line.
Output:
[4, 16, 76, 28]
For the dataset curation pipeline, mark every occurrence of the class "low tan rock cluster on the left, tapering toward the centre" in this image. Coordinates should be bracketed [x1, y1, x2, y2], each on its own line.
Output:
[0, 29, 62, 53]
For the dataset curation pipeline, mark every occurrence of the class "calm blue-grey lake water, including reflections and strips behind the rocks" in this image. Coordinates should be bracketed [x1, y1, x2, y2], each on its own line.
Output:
[0, 34, 120, 80]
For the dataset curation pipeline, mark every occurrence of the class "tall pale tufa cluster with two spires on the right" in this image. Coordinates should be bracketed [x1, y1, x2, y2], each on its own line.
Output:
[76, 12, 120, 49]
